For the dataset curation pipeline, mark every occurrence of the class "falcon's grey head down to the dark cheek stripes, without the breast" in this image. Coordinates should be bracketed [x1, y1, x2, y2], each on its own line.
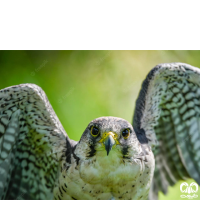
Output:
[75, 117, 140, 159]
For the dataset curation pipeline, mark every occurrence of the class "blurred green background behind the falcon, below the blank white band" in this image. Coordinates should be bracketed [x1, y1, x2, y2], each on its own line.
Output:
[0, 51, 200, 200]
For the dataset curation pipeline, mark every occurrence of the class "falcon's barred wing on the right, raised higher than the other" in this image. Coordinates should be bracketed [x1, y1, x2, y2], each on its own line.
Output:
[133, 63, 200, 199]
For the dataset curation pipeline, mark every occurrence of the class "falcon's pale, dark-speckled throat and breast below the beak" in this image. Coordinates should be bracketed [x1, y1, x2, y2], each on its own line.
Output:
[54, 145, 154, 200]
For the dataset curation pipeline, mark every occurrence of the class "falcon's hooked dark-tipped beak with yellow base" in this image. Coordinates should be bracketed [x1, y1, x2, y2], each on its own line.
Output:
[99, 132, 119, 156]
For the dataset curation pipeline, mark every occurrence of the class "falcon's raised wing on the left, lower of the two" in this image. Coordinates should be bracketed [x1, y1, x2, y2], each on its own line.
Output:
[0, 84, 73, 200]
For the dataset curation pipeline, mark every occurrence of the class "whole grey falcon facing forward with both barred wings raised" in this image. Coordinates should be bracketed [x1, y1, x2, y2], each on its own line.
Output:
[0, 63, 200, 200]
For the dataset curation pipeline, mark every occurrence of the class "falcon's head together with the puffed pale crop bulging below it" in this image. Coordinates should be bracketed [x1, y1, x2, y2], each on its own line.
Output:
[72, 117, 142, 185]
